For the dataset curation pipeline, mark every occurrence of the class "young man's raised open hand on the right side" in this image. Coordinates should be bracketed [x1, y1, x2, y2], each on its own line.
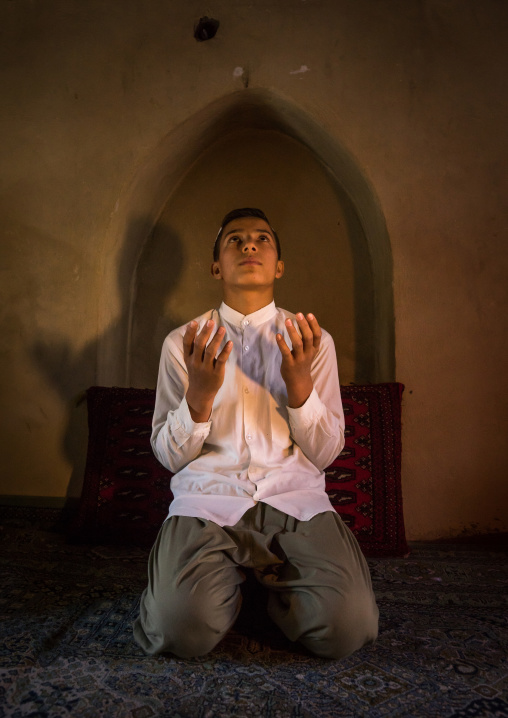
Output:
[276, 312, 321, 409]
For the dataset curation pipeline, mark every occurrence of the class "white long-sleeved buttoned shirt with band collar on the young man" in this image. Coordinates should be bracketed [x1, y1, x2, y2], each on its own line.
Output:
[151, 302, 344, 526]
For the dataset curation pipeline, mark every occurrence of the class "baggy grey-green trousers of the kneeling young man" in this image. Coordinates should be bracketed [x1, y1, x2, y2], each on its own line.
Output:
[134, 503, 379, 658]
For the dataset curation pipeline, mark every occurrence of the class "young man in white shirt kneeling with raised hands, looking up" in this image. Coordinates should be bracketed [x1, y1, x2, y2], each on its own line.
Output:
[134, 208, 378, 658]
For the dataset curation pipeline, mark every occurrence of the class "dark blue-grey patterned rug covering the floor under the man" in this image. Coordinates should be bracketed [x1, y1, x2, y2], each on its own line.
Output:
[0, 508, 508, 718]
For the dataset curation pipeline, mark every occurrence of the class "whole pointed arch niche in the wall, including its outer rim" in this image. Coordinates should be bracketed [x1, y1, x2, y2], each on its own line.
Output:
[98, 90, 395, 386]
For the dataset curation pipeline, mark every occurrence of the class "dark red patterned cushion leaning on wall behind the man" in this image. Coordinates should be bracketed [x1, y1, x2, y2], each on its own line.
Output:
[71, 383, 408, 556]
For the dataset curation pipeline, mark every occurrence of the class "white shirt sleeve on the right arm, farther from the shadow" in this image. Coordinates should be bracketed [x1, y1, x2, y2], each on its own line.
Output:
[287, 332, 345, 471]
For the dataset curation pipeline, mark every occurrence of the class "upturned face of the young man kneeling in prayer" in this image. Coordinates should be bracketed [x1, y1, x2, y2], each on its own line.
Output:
[212, 217, 284, 289]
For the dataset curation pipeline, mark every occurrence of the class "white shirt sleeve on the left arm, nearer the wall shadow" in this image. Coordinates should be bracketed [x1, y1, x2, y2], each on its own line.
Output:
[150, 330, 211, 473]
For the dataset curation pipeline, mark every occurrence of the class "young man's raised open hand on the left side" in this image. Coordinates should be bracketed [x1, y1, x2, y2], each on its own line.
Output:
[183, 319, 233, 422]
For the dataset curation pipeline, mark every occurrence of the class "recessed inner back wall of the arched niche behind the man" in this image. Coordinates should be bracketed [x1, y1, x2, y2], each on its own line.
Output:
[130, 131, 356, 386]
